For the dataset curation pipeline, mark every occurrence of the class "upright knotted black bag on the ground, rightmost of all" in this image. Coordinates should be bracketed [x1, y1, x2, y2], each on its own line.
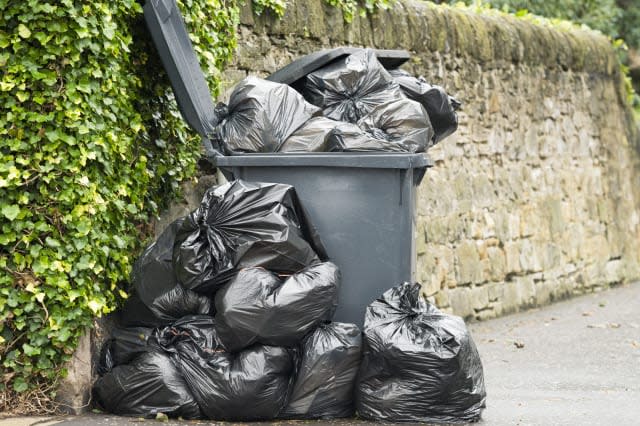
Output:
[356, 283, 486, 422]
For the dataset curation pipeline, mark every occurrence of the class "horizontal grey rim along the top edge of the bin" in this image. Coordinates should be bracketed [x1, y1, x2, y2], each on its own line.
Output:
[209, 152, 433, 169]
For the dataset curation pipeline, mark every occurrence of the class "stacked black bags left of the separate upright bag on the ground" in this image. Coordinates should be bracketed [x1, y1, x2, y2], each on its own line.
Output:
[93, 180, 362, 420]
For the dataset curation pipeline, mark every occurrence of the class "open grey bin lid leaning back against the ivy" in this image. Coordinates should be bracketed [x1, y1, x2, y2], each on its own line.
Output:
[144, 0, 218, 155]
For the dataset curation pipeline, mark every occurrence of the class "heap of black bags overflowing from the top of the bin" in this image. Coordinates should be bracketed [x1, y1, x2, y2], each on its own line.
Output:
[215, 49, 460, 155]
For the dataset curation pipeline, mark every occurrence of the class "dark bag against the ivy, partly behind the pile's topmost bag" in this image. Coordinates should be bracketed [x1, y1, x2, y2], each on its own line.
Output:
[120, 218, 211, 327]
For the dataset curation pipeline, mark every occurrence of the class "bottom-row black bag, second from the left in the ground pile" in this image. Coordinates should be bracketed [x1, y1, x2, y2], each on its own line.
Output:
[158, 316, 295, 420]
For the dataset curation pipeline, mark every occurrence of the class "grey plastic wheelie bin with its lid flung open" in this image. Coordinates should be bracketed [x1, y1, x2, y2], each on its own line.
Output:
[144, 0, 429, 325]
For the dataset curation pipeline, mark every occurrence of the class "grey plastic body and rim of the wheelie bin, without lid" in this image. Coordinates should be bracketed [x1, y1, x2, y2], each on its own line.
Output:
[214, 153, 429, 325]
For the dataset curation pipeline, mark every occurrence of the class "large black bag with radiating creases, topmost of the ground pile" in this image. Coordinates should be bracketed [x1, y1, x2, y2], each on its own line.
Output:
[173, 180, 326, 293]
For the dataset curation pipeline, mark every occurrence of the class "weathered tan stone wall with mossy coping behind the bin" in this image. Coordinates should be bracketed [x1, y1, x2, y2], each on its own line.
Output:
[212, 0, 640, 319]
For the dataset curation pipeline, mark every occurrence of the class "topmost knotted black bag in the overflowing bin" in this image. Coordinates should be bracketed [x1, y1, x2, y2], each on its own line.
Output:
[304, 49, 405, 123]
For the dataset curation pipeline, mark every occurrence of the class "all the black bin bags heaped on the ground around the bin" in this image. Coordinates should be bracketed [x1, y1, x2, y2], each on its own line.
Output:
[93, 180, 485, 422]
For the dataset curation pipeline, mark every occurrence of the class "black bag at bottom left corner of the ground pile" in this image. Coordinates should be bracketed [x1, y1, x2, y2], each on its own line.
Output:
[93, 351, 202, 419]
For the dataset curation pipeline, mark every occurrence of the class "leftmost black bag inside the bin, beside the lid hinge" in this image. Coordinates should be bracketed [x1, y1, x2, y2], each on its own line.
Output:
[215, 77, 320, 154]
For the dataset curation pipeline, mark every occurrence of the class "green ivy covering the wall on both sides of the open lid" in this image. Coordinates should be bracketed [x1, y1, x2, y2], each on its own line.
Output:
[0, 0, 238, 411]
